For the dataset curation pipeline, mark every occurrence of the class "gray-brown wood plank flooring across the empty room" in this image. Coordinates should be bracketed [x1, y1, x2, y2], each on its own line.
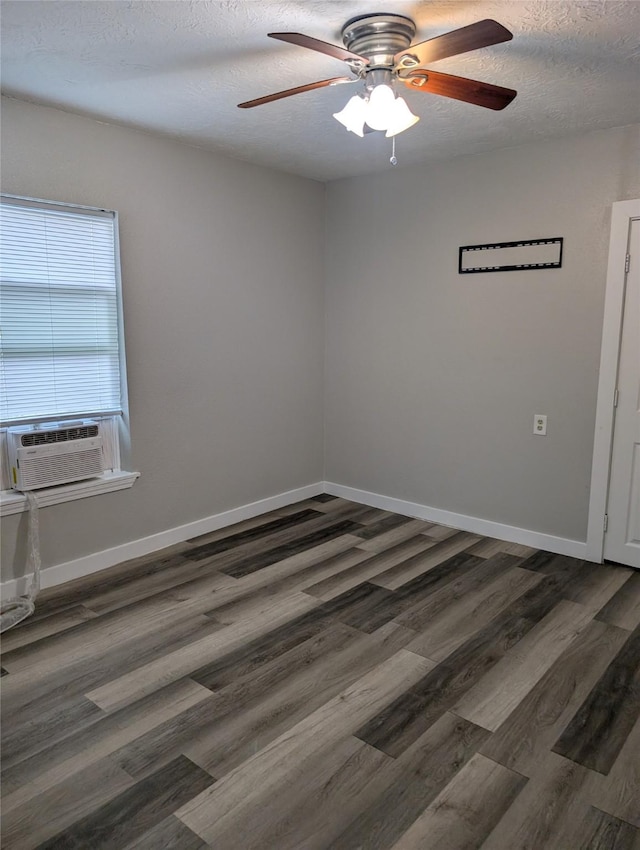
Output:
[0, 495, 640, 850]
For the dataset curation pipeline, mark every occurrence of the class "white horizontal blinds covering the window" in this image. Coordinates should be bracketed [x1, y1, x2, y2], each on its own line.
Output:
[0, 196, 122, 424]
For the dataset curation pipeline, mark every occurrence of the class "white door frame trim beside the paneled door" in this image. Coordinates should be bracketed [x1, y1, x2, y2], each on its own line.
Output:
[586, 199, 640, 563]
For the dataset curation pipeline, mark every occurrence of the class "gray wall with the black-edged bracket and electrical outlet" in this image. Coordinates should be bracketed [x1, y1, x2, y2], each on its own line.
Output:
[325, 126, 640, 540]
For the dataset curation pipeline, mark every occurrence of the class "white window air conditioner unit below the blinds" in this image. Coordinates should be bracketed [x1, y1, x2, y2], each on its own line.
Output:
[7, 421, 104, 491]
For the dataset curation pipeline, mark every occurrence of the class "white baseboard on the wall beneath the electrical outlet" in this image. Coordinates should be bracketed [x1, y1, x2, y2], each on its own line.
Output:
[324, 481, 587, 560]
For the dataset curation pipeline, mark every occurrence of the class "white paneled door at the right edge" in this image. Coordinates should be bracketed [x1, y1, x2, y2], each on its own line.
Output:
[604, 219, 640, 569]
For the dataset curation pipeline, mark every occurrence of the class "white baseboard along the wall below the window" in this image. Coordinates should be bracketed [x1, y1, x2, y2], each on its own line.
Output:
[0, 481, 324, 599]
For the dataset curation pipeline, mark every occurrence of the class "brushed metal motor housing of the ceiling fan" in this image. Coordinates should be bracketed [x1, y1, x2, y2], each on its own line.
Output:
[342, 14, 416, 68]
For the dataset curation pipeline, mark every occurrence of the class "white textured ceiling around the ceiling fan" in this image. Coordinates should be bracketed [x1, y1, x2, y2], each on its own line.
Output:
[1, 0, 640, 180]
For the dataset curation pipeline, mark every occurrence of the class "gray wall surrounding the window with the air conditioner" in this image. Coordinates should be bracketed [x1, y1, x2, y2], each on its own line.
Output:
[2, 99, 325, 580]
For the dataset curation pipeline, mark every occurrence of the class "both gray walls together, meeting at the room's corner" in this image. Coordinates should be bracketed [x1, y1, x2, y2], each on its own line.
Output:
[2, 99, 640, 580]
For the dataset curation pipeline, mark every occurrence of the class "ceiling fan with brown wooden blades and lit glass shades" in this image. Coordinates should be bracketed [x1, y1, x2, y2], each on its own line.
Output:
[238, 14, 517, 136]
